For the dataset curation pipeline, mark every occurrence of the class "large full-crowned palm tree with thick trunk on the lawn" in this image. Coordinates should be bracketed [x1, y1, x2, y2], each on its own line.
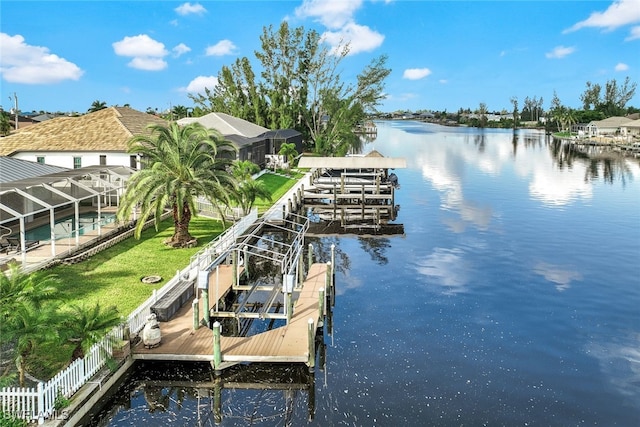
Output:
[118, 122, 236, 247]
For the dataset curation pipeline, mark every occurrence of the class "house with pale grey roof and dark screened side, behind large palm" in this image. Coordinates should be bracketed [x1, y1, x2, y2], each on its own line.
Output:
[177, 113, 303, 168]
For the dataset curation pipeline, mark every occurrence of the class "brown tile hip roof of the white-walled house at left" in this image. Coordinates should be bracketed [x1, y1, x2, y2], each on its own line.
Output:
[0, 107, 167, 156]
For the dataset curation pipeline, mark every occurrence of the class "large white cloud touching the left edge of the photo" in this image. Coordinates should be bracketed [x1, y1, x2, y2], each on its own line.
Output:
[0, 33, 84, 84]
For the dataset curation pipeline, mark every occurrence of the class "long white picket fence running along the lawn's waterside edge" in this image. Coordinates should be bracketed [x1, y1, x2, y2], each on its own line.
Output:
[0, 209, 258, 422]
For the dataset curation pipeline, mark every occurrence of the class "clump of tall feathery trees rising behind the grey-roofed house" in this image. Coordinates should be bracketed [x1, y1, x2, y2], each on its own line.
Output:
[190, 21, 391, 155]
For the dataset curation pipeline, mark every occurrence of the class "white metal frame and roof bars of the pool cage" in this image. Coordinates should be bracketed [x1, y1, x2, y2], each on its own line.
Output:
[0, 166, 135, 265]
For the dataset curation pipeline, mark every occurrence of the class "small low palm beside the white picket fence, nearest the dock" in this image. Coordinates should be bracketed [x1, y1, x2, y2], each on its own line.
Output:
[61, 304, 121, 362]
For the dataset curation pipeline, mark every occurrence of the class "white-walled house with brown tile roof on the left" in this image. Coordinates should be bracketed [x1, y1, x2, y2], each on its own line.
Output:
[0, 107, 167, 169]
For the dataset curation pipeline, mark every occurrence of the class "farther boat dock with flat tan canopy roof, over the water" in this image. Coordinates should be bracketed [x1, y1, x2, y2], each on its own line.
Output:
[299, 151, 406, 235]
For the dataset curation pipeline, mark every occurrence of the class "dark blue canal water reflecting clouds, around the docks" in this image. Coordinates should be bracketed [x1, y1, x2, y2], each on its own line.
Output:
[86, 121, 640, 426]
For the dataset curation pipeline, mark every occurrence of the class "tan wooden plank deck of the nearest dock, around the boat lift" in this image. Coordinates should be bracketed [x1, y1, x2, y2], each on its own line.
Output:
[132, 264, 327, 368]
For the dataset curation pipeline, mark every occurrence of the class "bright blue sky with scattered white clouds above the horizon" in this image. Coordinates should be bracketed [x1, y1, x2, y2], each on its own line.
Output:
[0, 0, 640, 112]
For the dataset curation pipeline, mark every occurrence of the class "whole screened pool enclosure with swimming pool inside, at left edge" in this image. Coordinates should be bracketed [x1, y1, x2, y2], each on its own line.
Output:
[0, 166, 135, 264]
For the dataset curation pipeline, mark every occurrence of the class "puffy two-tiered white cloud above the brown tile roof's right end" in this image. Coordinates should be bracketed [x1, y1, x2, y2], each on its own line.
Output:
[112, 34, 169, 71]
